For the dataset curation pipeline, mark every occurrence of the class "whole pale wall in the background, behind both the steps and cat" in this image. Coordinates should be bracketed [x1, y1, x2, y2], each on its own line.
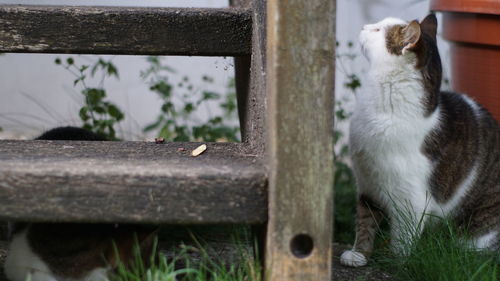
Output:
[0, 0, 447, 139]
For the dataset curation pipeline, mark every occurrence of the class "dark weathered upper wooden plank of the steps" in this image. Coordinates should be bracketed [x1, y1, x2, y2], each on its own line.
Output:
[0, 5, 252, 56]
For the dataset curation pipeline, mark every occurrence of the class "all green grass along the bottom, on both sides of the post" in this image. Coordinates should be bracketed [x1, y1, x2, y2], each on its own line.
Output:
[109, 212, 500, 281]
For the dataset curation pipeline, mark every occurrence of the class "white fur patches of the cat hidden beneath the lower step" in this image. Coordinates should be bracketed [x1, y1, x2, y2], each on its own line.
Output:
[4, 229, 107, 281]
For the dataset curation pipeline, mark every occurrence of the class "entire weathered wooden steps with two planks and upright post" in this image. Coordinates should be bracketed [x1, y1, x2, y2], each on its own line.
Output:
[0, 0, 335, 281]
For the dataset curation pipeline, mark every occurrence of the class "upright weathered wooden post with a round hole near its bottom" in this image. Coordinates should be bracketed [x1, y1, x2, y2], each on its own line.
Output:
[266, 0, 335, 281]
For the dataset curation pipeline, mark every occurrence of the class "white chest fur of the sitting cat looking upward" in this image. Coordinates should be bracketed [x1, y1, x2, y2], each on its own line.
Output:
[350, 74, 439, 212]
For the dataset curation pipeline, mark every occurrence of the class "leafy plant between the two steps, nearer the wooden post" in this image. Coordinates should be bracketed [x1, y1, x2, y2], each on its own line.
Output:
[141, 57, 239, 142]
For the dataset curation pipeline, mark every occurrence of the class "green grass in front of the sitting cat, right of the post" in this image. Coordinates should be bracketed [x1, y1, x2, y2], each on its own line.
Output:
[373, 219, 500, 281]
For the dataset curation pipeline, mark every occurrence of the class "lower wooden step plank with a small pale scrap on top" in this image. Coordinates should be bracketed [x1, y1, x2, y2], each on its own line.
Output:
[0, 140, 267, 224]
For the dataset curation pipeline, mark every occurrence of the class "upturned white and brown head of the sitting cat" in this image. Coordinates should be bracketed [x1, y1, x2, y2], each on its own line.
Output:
[359, 14, 442, 108]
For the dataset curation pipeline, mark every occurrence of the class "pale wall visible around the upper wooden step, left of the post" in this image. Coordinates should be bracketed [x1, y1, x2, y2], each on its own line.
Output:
[0, 0, 234, 139]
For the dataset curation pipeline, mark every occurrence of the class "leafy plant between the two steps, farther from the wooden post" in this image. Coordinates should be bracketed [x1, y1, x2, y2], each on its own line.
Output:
[55, 57, 125, 140]
